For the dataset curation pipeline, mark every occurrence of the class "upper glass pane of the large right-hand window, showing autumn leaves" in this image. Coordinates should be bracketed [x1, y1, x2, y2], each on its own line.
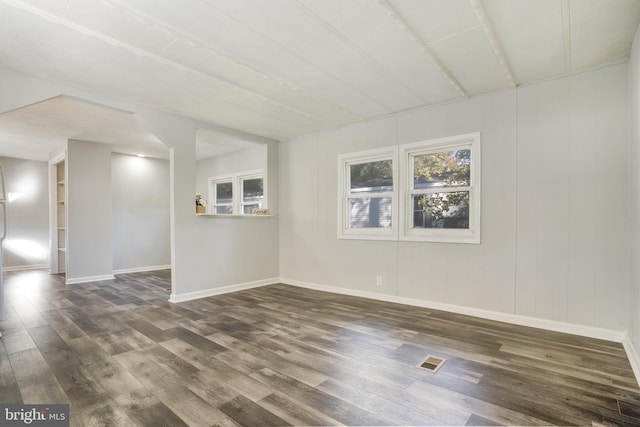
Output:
[413, 149, 471, 189]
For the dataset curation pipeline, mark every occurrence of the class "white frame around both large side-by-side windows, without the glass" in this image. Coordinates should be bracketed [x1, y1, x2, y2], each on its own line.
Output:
[338, 132, 482, 244]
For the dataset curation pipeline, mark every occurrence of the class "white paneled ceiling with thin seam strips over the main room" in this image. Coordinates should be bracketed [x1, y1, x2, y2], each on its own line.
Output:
[0, 0, 640, 160]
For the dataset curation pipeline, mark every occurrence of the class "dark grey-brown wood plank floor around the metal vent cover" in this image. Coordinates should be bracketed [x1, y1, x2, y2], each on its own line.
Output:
[0, 271, 640, 426]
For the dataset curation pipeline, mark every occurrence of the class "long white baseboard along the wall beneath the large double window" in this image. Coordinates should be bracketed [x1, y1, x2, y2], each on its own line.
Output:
[280, 278, 626, 343]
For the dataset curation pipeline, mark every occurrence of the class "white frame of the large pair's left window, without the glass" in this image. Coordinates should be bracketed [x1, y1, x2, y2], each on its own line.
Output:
[338, 147, 398, 240]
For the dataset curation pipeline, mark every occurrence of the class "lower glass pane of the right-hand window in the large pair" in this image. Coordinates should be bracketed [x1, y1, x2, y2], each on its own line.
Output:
[413, 191, 469, 229]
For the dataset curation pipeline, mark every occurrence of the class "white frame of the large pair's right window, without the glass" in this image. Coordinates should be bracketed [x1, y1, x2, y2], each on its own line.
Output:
[399, 132, 482, 244]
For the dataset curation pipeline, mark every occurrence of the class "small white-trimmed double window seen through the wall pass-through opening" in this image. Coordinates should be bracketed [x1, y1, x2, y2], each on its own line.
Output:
[209, 170, 267, 215]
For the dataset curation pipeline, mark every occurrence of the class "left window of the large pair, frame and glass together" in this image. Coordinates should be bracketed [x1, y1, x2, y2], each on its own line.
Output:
[338, 149, 398, 239]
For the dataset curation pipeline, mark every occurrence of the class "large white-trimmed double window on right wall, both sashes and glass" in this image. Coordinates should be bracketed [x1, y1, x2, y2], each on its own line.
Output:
[338, 133, 480, 243]
